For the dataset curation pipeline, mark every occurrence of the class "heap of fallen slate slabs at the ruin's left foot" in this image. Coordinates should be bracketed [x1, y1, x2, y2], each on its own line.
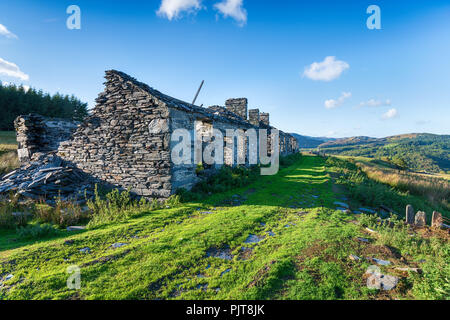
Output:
[0, 153, 96, 204]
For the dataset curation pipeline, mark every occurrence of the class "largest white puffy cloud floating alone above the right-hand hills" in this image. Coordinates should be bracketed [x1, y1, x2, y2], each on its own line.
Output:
[303, 56, 350, 81]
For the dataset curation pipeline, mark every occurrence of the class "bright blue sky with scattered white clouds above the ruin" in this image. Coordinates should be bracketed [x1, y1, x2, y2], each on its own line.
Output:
[0, 0, 450, 137]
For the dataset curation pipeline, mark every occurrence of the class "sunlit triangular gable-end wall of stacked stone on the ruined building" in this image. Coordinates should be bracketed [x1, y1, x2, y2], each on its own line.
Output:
[58, 71, 172, 198]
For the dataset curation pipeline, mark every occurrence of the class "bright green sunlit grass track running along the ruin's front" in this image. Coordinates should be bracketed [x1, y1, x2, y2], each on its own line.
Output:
[0, 156, 449, 299]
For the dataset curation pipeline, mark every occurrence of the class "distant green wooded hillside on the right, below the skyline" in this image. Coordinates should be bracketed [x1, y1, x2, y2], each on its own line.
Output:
[318, 133, 450, 173]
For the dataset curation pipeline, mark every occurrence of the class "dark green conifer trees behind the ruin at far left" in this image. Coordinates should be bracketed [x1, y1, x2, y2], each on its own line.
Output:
[0, 82, 88, 131]
